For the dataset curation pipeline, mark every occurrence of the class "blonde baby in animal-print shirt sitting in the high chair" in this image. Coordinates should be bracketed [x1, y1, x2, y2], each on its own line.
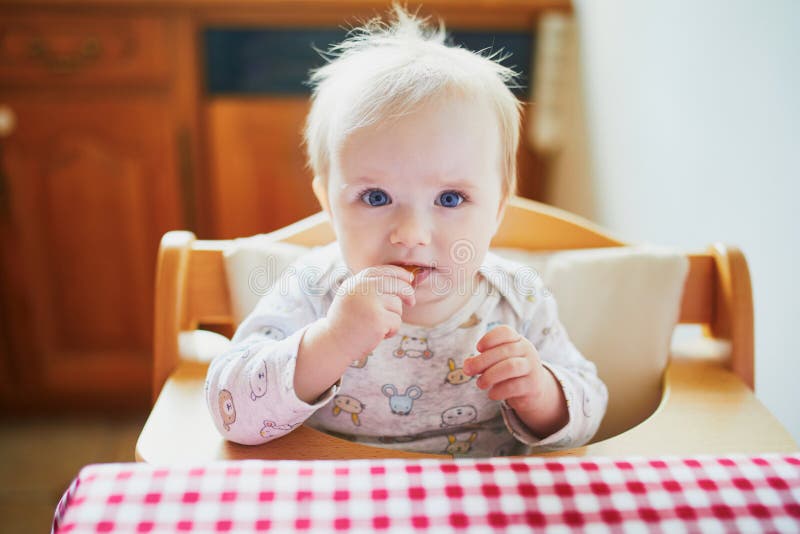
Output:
[206, 4, 607, 457]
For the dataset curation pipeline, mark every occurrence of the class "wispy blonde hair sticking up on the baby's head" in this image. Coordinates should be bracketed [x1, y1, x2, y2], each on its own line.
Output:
[304, 5, 522, 196]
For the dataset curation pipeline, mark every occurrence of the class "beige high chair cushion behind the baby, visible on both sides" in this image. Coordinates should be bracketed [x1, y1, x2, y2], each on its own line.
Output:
[225, 242, 689, 441]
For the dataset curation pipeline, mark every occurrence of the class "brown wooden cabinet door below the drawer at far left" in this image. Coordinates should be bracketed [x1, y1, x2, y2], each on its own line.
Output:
[0, 93, 181, 407]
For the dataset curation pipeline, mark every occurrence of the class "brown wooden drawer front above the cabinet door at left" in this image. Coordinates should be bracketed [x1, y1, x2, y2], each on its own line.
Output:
[0, 12, 169, 85]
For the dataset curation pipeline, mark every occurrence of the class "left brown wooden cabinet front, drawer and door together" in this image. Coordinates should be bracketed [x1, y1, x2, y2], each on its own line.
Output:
[0, 14, 183, 410]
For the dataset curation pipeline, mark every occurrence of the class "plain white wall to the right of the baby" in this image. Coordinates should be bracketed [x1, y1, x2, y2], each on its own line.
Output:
[549, 0, 800, 442]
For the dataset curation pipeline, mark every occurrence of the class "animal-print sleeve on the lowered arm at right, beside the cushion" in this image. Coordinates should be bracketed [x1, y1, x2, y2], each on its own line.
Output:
[502, 283, 608, 450]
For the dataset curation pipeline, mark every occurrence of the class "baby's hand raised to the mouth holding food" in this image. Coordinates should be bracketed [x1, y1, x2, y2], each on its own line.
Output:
[327, 265, 415, 361]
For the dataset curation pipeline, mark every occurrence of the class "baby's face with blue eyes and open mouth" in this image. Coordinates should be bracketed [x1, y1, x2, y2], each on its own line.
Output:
[327, 98, 503, 314]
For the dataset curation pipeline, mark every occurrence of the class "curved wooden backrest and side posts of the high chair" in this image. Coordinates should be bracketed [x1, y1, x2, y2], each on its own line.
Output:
[152, 197, 753, 440]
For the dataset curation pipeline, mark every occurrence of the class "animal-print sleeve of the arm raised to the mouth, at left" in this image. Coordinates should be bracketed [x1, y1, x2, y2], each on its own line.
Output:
[206, 269, 337, 445]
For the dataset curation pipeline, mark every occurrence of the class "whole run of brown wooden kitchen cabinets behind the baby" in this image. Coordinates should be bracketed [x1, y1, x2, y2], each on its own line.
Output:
[0, 0, 568, 413]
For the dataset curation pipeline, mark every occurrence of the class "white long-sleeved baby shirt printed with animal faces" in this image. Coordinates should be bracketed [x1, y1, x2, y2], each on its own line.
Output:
[206, 243, 608, 457]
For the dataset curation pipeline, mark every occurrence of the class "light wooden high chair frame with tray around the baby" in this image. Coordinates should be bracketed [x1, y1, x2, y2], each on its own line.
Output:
[136, 198, 797, 464]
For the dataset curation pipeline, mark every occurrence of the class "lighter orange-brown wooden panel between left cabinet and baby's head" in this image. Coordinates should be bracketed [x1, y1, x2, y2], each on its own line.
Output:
[207, 98, 319, 239]
